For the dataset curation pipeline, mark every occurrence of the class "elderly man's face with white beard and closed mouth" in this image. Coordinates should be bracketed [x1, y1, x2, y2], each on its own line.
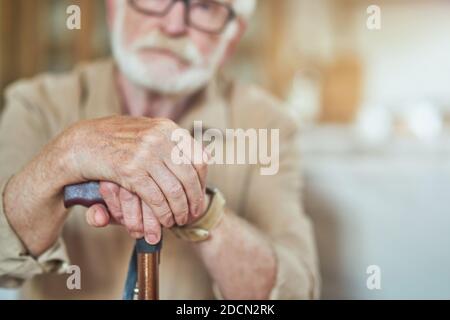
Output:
[108, 0, 240, 94]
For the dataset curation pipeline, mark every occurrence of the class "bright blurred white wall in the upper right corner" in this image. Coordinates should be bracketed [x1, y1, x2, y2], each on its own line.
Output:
[352, 0, 450, 108]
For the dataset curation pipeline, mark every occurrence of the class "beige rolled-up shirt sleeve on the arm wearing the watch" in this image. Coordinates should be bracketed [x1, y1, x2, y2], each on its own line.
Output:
[244, 124, 320, 300]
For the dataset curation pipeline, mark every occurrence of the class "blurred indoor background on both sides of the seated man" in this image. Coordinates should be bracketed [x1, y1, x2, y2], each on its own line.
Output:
[0, 0, 450, 299]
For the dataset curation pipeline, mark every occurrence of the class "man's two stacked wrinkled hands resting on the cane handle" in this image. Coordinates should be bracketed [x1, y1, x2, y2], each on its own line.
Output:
[66, 117, 208, 244]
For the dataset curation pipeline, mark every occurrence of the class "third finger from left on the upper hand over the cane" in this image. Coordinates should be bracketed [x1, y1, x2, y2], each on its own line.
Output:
[165, 155, 204, 218]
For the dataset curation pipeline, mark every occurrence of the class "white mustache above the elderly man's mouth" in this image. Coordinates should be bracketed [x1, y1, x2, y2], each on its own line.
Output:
[131, 32, 203, 66]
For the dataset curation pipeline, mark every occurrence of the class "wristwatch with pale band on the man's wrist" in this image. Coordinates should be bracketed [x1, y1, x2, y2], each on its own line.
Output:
[171, 187, 225, 242]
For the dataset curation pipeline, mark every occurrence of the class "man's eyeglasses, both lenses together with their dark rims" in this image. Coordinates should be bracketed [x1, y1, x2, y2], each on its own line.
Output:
[129, 0, 236, 34]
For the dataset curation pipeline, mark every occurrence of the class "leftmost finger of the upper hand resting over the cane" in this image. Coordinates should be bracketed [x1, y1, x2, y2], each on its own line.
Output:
[132, 175, 175, 228]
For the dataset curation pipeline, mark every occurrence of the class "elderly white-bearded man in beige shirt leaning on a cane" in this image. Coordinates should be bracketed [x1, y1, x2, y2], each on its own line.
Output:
[0, 0, 319, 299]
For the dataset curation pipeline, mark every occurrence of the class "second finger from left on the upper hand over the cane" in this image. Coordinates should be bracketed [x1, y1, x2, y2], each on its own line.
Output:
[150, 162, 189, 226]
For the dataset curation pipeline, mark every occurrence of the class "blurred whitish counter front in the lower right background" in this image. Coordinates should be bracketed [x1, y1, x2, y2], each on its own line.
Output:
[301, 127, 450, 299]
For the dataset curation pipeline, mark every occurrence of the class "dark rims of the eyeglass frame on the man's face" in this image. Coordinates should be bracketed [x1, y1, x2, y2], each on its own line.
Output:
[128, 0, 237, 35]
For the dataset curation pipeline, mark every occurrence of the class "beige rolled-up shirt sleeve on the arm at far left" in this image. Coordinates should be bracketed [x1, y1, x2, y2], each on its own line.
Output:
[0, 83, 68, 288]
